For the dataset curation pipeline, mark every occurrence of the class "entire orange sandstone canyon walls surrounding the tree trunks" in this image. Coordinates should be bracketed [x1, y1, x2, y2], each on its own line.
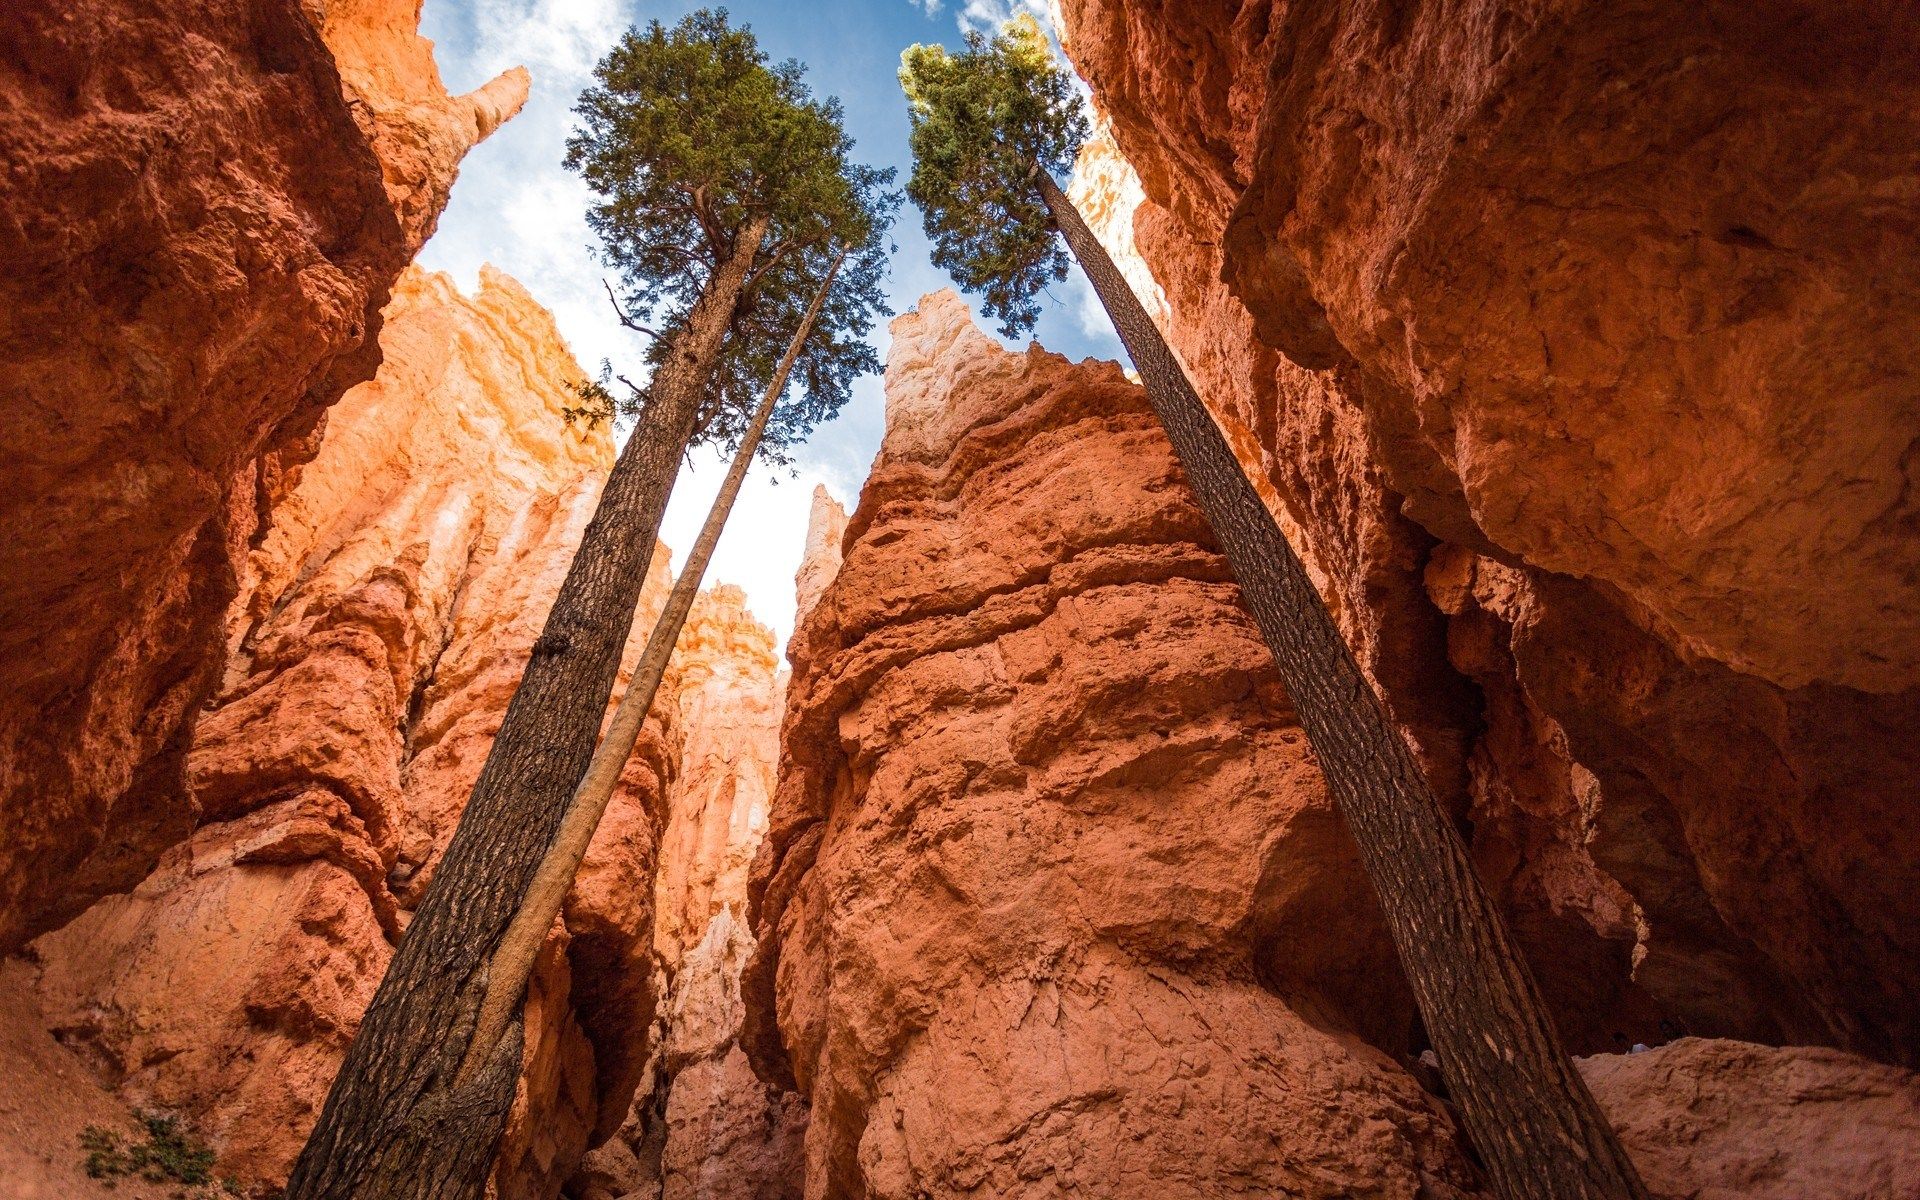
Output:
[0, 0, 1920, 1200]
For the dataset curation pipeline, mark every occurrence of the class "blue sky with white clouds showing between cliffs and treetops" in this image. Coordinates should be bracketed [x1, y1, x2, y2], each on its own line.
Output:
[420, 0, 1121, 641]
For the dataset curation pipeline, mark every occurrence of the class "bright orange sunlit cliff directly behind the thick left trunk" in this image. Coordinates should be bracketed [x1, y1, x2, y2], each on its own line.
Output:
[31, 269, 678, 1196]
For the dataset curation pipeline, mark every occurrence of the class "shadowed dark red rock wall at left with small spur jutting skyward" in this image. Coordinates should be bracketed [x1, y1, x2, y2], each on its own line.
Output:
[0, 0, 526, 950]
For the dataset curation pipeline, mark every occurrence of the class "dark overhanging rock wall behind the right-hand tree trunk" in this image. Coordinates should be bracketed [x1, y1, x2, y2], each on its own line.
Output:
[1062, 0, 1920, 1064]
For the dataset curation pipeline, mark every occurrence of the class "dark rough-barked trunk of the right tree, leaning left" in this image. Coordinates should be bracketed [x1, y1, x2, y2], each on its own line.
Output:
[1035, 171, 1647, 1200]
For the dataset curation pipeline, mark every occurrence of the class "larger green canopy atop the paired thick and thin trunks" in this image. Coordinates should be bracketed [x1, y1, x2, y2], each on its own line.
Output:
[566, 8, 899, 461]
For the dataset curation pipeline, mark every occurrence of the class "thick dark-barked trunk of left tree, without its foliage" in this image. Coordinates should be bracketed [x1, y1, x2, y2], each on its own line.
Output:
[286, 217, 768, 1200]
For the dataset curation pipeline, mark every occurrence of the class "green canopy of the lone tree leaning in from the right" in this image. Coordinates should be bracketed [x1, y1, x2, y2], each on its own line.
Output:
[900, 15, 1087, 338]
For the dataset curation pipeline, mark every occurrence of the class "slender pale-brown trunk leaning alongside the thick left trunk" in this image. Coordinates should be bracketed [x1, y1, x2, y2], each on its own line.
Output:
[457, 252, 847, 1083]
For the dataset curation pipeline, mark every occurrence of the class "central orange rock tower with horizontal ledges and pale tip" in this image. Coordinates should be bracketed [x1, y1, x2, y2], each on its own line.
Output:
[745, 292, 1475, 1198]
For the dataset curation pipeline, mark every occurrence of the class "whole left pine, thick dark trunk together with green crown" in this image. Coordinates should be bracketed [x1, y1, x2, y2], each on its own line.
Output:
[286, 12, 891, 1200]
